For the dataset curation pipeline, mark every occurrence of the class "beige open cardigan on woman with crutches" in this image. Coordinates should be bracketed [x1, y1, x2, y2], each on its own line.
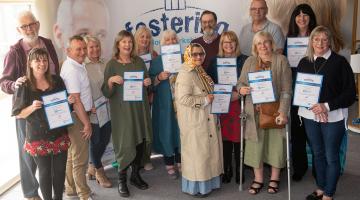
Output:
[236, 53, 292, 141]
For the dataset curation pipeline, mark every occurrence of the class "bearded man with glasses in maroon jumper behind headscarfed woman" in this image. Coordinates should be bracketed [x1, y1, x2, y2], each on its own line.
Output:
[191, 10, 220, 70]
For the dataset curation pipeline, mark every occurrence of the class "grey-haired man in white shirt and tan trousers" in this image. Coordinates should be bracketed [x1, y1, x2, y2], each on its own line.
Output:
[60, 35, 93, 200]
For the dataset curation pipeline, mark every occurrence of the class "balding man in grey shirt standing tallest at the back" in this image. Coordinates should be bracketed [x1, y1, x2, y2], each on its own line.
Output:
[239, 0, 285, 56]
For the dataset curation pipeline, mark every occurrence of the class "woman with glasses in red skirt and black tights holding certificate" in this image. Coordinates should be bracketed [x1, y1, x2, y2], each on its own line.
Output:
[208, 31, 247, 183]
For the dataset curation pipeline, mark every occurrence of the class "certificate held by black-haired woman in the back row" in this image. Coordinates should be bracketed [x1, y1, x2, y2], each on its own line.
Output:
[287, 37, 309, 67]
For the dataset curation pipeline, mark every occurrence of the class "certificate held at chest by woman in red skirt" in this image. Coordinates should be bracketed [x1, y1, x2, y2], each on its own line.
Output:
[216, 58, 237, 86]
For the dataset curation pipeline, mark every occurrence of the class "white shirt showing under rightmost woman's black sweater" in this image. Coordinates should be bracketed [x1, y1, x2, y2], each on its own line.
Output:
[298, 49, 348, 122]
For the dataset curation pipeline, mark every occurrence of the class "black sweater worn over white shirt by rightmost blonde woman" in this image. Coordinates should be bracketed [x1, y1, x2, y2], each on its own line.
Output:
[297, 51, 356, 111]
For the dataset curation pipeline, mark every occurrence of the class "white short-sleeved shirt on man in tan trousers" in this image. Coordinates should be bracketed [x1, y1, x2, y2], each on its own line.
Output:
[60, 57, 93, 112]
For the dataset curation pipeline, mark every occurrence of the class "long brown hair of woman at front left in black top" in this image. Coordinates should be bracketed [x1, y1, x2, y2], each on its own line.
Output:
[26, 48, 54, 91]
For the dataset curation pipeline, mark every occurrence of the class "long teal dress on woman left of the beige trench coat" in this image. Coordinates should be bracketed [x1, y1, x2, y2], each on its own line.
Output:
[149, 56, 180, 157]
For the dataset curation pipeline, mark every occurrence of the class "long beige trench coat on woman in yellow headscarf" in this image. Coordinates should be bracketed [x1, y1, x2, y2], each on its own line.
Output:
[175, 65, 223, 181]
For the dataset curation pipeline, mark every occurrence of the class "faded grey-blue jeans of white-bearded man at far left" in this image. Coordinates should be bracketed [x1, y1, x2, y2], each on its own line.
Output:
[15, 119, 39, 198]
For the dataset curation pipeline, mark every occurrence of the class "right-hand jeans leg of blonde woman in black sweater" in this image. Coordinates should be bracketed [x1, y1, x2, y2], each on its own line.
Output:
[322, 120, 345, 197]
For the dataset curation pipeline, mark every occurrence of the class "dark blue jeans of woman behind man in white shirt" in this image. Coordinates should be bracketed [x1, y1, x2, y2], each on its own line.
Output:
[90, 122, 111, 169]
